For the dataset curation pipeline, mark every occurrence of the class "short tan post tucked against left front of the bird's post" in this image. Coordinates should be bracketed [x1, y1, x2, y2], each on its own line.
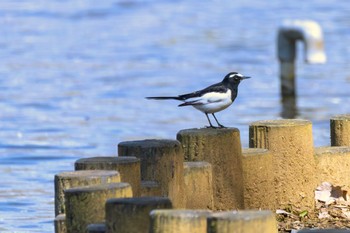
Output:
[184, 161, 214, 210]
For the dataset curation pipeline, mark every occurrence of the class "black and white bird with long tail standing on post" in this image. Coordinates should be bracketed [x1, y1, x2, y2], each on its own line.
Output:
[146, 72, 250, 128]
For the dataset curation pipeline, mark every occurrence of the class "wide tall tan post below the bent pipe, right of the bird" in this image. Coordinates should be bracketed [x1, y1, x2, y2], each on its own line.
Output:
[249, 119, 317, 210]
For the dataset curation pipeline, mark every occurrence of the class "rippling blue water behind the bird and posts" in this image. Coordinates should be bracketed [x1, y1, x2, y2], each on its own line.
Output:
[0, 0, 350, 232]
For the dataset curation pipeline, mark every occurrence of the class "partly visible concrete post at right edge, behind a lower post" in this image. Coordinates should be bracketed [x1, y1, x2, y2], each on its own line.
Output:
[330, 114, 350, 146]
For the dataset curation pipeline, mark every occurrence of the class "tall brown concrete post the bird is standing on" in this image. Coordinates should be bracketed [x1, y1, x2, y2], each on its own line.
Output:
[177, 128, 244, 210]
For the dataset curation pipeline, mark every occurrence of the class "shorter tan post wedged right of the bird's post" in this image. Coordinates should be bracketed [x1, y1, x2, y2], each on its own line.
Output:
[242, 148, 275, 210]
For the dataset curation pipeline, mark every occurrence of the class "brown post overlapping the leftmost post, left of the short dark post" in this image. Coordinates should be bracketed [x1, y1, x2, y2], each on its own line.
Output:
[65, 183, 132, 233]
